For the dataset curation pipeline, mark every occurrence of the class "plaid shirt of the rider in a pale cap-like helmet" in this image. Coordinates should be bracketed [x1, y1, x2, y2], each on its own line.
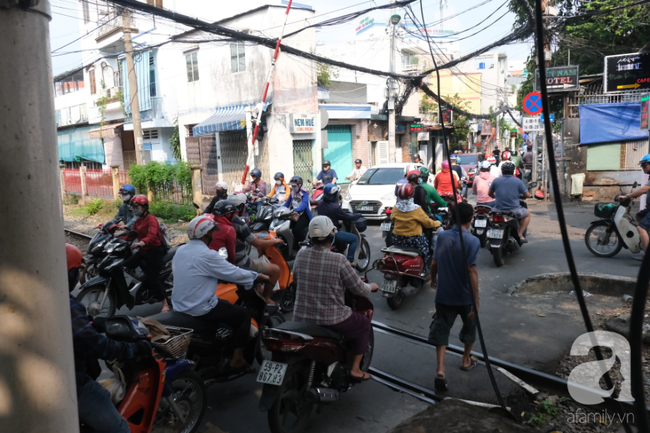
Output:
[293, 246, 371, 325]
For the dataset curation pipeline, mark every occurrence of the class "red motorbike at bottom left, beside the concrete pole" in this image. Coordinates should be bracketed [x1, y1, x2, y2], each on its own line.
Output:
[81, 316, 208, 433]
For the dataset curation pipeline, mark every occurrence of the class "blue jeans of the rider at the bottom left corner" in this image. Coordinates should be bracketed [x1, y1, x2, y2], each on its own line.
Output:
[77, 378, 131, 433]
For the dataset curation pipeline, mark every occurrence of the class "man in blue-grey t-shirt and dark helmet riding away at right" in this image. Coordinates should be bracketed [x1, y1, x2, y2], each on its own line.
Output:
[488, 162, 530, 244]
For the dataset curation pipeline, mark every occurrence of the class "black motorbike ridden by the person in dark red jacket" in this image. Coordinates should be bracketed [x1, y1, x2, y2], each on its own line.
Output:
[77, 238, 180, 317]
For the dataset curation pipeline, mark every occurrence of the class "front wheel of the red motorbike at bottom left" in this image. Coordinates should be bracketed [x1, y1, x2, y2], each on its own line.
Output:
[151, 370, 208, 433]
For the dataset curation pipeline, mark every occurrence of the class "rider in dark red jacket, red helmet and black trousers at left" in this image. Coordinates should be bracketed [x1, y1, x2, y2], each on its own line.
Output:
[123, 195, 169, 313]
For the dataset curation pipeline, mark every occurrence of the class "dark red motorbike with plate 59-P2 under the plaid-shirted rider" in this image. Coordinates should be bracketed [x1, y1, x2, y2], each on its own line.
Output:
[257, 284, 374, 433]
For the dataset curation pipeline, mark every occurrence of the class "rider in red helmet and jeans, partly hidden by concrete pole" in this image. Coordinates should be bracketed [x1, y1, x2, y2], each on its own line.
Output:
[65, 244, 151, 433]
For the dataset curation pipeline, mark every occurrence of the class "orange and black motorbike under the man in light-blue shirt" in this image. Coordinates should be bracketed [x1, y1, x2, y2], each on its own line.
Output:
[151, 274, 285, 386]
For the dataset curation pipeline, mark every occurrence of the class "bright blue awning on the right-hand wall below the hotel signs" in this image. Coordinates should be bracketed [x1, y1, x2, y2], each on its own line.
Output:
[579, 102, 648, 146]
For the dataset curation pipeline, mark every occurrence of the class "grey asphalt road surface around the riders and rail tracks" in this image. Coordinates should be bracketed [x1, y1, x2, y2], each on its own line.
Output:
[109, 202, 640, 433]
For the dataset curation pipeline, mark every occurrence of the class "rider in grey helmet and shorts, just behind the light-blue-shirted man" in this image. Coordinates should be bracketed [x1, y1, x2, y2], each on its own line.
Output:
[223, 193, 283, 304]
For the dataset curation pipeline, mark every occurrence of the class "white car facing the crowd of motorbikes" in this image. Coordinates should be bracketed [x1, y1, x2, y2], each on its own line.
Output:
[341, 162, 424, 220]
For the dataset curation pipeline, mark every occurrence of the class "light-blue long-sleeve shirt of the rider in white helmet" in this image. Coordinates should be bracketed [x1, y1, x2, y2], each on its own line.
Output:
[172, 239, 257, 317]
